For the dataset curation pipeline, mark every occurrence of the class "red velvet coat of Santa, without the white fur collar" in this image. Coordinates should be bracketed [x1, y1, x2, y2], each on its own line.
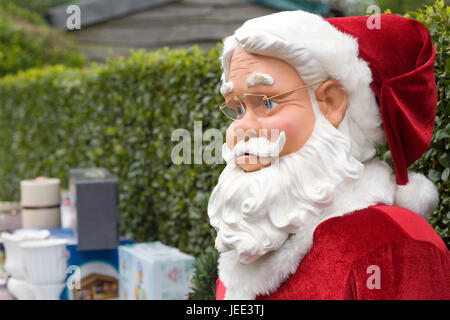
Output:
[216, 206, 450, 300]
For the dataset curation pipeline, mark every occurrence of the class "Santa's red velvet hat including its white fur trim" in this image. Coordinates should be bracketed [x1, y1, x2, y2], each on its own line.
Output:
[222, 11, 437, 185]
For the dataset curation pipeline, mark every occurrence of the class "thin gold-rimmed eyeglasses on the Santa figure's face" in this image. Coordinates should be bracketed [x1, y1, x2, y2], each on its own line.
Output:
[219, 78, 329, 120]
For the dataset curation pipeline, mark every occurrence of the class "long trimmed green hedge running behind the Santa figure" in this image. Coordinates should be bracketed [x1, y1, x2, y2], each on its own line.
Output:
[0, 3, 450, 255]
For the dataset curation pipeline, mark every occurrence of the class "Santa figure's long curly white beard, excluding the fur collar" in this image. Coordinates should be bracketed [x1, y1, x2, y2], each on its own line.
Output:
[208, 118, 364, 264]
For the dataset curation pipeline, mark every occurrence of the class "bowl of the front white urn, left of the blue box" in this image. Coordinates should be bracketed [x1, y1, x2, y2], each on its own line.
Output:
[20, 239, 68, 285]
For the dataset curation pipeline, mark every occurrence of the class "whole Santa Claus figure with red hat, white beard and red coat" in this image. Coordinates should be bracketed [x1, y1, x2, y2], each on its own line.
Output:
[208, 11, 450, 299]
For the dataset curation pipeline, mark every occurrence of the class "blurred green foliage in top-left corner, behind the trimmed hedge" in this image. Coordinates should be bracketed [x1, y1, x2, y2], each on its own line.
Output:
[0, 3, 85, 77]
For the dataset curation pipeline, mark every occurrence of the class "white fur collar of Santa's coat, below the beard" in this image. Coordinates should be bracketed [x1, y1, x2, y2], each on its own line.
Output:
[219, 159, 396, 299]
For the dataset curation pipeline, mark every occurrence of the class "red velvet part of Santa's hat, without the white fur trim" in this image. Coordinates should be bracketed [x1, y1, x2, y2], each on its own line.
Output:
[326, 14, 437, 185]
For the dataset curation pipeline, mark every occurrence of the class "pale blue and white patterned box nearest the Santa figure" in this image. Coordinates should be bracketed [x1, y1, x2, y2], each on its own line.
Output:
[119, 242, 195, 300]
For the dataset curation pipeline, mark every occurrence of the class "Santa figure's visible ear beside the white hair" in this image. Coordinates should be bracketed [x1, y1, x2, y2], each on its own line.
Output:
[316, 80, 348, 128]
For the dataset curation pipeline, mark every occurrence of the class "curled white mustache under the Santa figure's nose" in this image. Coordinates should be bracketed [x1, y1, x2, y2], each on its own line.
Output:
[222, 131, 286, 163]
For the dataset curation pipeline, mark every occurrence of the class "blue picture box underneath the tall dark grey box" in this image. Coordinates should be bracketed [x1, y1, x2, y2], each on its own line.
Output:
[50, 228, 133, 300]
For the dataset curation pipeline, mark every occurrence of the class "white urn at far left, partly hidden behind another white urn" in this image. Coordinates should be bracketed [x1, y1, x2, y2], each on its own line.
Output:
[1, 230, 50, 279]
